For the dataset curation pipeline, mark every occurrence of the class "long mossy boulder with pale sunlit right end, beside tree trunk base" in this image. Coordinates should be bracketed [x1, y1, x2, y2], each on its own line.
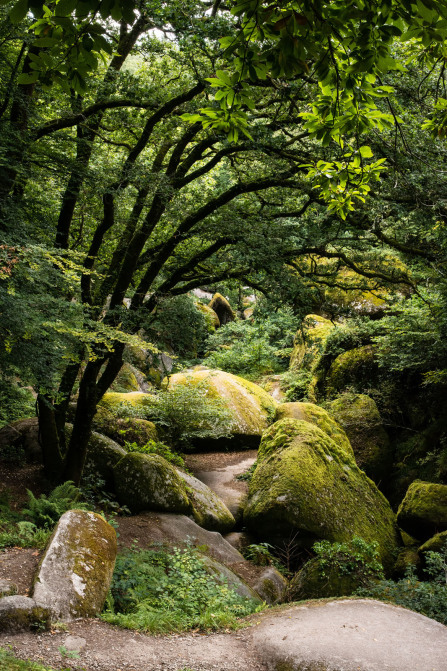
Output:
[114, 452, 235, 532]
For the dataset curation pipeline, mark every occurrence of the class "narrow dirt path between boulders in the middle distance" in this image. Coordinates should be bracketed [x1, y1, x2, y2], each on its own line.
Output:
[186, 450, 257, 517]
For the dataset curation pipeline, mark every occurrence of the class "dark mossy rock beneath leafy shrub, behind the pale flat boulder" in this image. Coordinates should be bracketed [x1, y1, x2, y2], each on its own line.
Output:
[289, 558, 362, 601]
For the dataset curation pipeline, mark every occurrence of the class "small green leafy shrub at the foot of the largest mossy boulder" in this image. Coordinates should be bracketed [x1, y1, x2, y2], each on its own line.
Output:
[312, 536, 383, 584]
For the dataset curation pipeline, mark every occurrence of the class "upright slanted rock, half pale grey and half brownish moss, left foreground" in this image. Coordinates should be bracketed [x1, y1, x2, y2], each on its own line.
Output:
[32, 510, 117, 620]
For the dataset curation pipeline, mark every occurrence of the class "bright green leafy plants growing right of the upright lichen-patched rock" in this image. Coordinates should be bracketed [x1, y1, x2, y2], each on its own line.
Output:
[102, 548, 259, 633]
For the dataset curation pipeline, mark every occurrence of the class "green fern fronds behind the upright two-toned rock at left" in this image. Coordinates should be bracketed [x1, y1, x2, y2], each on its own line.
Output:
[22, 481, 86, 529]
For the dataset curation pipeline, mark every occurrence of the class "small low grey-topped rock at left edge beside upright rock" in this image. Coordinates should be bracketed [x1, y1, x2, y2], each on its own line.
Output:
[0, 596, 50, 632]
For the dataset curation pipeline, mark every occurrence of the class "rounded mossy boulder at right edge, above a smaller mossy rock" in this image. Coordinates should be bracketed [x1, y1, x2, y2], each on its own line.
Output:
[397, 480, 447, 541]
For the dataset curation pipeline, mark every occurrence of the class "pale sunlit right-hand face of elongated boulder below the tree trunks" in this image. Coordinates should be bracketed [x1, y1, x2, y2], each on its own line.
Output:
[177, 470, 236, 533]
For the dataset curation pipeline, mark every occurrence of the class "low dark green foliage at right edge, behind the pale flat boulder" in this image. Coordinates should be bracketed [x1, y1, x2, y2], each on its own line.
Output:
[358, 548, 447, 624]
